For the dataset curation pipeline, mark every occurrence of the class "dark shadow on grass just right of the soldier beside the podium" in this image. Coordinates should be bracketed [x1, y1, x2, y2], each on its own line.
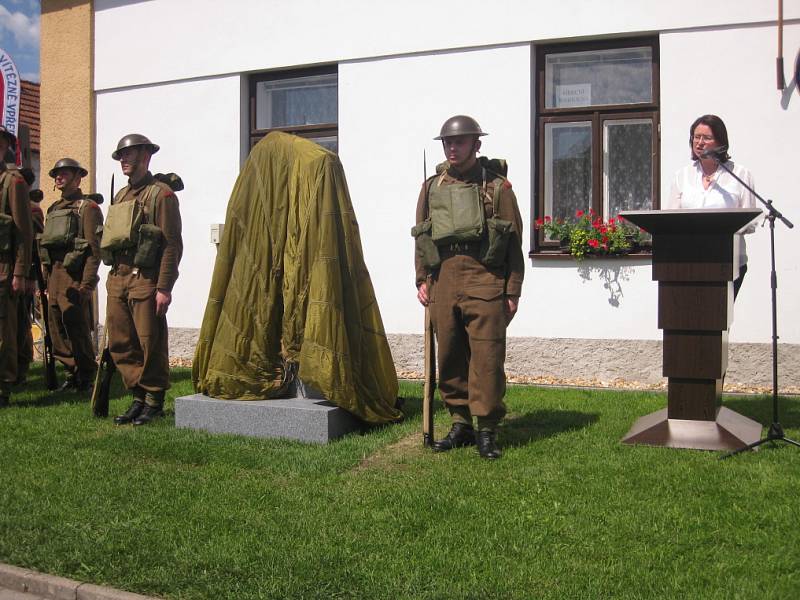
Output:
[497, 410, 600, 446]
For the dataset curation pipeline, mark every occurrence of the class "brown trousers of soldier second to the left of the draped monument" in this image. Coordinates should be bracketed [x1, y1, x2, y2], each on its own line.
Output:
[47, 262, 97, 381]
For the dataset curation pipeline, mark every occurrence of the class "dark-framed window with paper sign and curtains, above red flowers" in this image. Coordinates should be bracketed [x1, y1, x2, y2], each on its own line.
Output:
[532, 38, 659, 253]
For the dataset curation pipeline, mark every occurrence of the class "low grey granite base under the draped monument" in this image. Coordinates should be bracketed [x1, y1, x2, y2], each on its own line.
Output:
[175, 394, 361, 444]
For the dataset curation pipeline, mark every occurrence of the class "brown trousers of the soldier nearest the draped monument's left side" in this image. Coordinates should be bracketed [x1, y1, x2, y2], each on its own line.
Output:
[106, 265, 169, 392]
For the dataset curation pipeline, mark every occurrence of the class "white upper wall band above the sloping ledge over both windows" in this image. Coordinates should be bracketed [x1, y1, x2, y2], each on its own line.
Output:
[94, 0, 800, 90]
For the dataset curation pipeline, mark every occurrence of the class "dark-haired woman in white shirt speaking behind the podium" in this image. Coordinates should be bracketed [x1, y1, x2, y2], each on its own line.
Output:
[663, 115, 756, 299]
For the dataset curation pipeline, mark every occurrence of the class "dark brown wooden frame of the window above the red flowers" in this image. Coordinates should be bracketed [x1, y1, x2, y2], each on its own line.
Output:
[529, 36, 661, 258]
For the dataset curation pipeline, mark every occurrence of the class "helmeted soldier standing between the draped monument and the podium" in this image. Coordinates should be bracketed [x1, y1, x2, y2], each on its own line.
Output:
[412, 115, 525, 459]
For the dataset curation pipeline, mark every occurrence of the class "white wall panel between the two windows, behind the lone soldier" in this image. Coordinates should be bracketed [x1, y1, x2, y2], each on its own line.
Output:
[339, 44, 531, 335]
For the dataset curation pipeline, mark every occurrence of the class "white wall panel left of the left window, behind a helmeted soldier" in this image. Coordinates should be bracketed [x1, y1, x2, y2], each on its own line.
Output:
[96, 76, 243, 327]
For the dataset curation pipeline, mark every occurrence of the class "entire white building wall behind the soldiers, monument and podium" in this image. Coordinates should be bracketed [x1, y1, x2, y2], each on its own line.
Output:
[90, 0, 800, 343]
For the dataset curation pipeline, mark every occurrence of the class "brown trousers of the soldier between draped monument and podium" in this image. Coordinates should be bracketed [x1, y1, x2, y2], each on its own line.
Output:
[430, 255, 507, 421]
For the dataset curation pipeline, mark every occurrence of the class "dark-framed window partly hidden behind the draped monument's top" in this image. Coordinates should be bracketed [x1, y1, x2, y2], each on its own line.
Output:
[250, 65, 339, 152]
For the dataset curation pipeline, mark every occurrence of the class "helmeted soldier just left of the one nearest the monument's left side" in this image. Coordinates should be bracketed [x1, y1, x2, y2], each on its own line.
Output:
[39, 158, 103, 391]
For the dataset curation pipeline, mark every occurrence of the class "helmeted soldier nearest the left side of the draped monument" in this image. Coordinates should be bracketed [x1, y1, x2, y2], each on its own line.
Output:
[101, 133, 183, 425]
